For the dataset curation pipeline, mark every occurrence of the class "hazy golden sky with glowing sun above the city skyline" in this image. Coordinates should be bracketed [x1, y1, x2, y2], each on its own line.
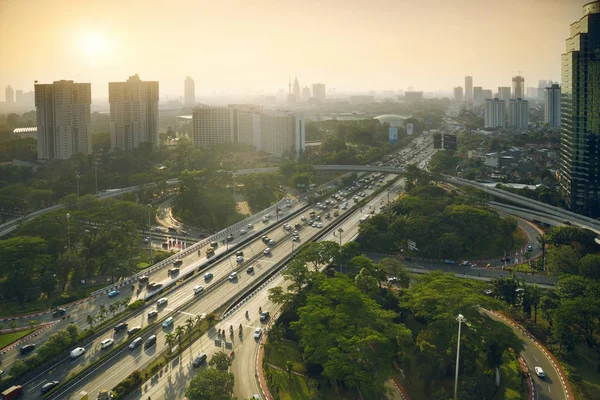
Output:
[0, 0, 589, 100]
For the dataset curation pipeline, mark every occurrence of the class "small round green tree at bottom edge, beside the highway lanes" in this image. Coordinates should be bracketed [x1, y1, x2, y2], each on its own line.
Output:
[186, 368, 235, 400]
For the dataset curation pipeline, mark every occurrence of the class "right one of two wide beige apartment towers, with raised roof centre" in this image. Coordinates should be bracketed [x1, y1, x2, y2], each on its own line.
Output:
[108, 74, 159, 150]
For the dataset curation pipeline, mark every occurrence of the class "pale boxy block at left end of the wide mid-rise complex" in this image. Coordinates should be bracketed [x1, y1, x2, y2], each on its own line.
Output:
[192, 107, 234, 146]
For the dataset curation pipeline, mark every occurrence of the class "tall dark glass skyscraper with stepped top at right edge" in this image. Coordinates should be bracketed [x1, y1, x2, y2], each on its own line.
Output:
[558, 1, 600, 217]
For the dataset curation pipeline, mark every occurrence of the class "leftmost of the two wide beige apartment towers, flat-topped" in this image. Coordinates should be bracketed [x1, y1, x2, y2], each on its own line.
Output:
[35, 81, 92, 161]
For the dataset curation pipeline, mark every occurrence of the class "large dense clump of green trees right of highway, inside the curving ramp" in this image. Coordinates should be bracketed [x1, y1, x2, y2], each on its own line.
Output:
[265, 242, 522, 399]
